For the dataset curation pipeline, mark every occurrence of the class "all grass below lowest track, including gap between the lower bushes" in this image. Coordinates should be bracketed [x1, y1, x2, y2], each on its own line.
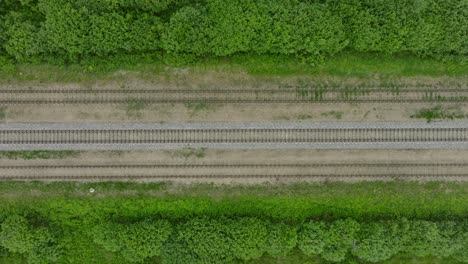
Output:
[0, 182, 468, 263]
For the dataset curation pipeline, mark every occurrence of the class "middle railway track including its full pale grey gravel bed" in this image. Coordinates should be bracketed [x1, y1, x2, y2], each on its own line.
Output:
[0, 123, 468, 150]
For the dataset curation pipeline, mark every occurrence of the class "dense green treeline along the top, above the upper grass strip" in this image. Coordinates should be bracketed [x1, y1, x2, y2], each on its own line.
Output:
[0, 0, 468, 63]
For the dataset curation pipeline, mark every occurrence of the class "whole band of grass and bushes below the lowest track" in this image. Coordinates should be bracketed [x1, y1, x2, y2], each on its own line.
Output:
[0, 182, 468, 263]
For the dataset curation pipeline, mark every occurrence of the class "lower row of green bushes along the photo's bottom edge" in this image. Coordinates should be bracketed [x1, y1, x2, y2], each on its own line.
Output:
[0, 215, 468, 263]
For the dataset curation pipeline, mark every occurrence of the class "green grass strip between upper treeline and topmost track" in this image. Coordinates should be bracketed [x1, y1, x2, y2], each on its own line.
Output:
[0, 52, 468, 82]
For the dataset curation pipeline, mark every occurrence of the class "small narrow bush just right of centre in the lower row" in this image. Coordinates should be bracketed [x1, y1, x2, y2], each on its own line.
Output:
[265, 223, 297, 257]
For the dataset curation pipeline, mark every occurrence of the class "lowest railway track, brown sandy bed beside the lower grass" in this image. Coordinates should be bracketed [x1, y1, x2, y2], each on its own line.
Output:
[0, 163, 468, 180]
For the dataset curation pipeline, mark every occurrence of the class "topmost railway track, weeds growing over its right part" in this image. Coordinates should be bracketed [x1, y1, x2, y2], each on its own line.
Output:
[0, 88, 468, 102]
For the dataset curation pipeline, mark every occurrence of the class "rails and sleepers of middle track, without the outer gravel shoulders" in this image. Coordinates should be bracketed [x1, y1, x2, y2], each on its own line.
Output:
[0, 128, 468, 145]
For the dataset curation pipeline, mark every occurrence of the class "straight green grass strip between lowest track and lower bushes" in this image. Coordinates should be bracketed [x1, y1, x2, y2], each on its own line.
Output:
[0, 182, 468, 221]
